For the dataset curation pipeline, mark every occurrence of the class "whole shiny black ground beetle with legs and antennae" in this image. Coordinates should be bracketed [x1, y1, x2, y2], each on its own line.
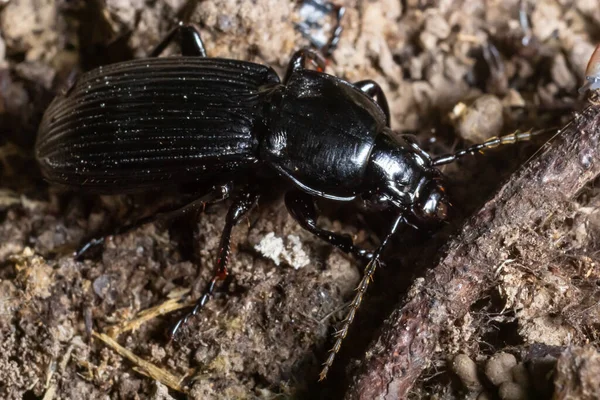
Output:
[35, 24, 532, 378]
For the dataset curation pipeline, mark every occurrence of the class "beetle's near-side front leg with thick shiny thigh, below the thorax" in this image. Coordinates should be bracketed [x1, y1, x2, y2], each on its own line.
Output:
[285, 190, 373, 260]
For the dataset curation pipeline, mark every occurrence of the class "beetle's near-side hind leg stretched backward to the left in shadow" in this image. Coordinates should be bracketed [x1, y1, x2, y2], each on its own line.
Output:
[75, 182, 233, 260]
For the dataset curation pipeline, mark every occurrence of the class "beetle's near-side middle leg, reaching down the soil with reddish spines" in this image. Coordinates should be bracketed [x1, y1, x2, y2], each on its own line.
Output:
[169, 186, 260, 339]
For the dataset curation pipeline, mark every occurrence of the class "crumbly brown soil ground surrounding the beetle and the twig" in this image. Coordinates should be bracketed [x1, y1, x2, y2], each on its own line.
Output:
[0, 0, 600, 400]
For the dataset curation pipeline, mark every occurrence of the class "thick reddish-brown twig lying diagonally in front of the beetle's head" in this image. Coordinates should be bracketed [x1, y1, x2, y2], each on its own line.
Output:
[346, 105, 600, 399]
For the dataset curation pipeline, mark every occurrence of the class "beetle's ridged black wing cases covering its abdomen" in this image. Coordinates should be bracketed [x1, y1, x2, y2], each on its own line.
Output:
[36, 57, 279, 193]
